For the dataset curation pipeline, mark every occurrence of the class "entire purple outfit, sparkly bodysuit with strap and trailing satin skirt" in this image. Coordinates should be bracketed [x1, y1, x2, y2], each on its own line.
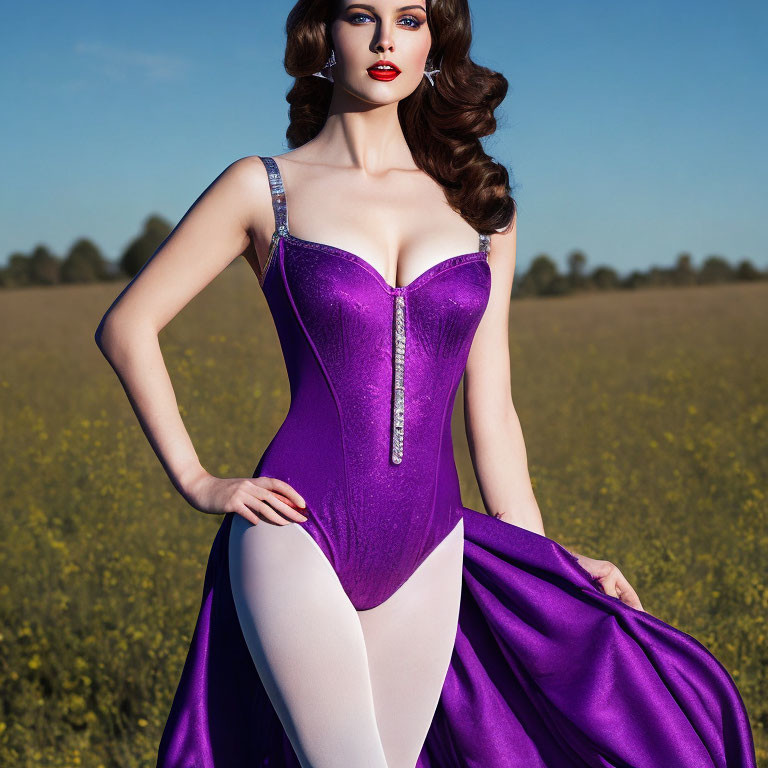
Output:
[158, 158, 755, 768]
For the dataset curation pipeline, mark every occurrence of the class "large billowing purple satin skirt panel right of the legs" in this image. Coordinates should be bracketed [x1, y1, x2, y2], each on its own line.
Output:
[418, 508, 756, 768]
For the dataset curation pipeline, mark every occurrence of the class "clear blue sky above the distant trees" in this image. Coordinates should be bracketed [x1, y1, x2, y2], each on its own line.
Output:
[0, 0, 768, 274]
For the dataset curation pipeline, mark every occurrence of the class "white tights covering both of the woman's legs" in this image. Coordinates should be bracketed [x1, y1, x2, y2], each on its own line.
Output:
[229, 515, 464, 768]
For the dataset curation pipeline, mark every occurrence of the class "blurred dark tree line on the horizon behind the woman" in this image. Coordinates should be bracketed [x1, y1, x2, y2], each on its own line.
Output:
[0, 215, 768, 298]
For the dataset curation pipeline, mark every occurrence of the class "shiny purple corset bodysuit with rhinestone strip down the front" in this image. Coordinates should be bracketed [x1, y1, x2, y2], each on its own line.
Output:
[255, 226, 491, 609]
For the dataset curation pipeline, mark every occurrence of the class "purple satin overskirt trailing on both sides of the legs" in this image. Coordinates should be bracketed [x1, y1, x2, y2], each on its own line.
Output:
[158, 507, 756, 768]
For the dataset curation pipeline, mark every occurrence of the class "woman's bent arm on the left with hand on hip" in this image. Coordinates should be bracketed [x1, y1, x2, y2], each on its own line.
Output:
[95, 156, 306, 524]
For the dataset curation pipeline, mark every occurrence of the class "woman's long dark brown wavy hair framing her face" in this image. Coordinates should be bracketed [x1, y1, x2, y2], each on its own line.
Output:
[283, 0, 517, 234]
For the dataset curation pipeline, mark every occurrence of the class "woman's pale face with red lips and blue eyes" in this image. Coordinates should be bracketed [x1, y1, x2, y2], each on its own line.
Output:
[331, 0, 432, 104]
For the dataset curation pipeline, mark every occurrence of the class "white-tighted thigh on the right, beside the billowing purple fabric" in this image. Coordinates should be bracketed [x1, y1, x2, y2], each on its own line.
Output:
[358, 520, 464, 768]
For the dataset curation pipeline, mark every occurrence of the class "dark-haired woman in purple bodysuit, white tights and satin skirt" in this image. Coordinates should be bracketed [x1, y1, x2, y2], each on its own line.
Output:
[94, 0, 754, 768]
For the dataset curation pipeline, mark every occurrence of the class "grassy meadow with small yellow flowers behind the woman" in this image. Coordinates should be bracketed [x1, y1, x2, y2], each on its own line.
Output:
[0, 260, 768, 768]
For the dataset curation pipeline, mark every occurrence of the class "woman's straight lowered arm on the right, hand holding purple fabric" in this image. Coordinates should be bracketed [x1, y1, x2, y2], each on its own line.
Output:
[464, 216, 644, 611]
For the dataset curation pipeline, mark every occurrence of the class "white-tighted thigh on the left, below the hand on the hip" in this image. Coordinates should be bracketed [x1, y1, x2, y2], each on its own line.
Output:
[229, 515, 387, 768]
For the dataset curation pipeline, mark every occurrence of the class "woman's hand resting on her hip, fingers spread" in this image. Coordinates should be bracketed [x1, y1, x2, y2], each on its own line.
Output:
[185, 472, 307, 525]
